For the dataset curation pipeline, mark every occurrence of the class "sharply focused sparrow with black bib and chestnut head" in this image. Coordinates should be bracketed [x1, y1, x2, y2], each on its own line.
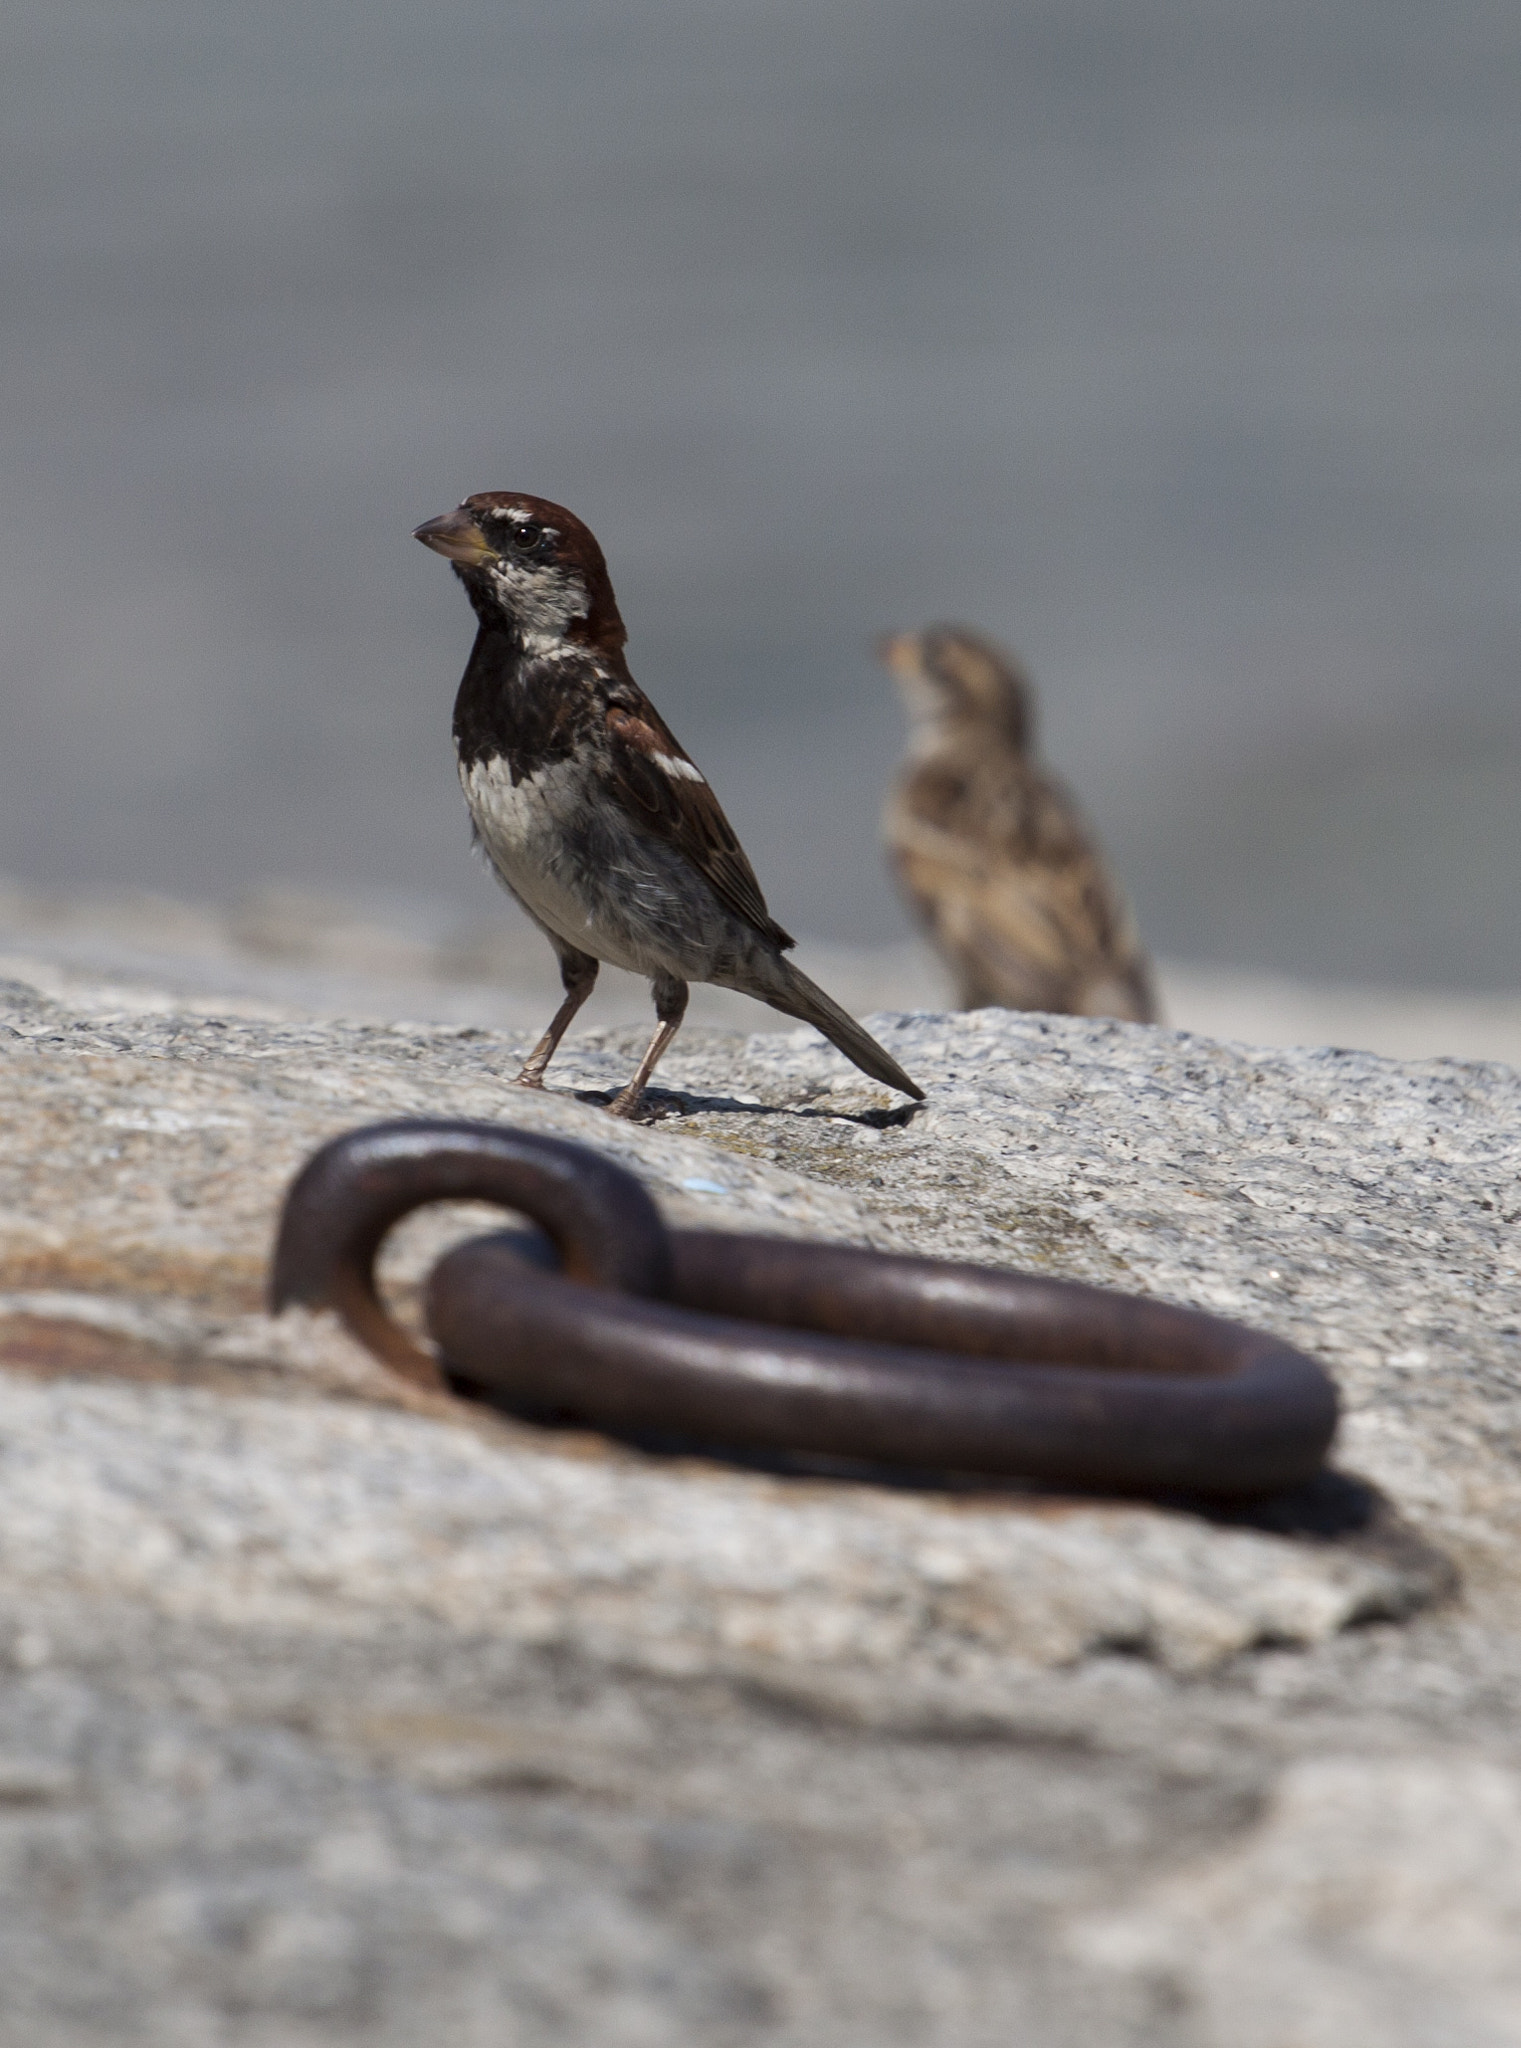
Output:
[416, 492, 923, 1116]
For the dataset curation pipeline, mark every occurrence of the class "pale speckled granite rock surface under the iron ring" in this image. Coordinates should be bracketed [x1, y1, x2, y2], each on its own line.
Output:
[0, 962, 1521, 2048]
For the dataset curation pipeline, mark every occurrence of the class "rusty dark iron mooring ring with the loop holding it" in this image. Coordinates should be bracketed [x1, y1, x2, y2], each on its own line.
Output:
[272, 1120, 1337, 1495]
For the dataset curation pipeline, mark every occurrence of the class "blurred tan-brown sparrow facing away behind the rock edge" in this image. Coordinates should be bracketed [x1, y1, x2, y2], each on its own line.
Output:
[878, 627, 1157, 1024]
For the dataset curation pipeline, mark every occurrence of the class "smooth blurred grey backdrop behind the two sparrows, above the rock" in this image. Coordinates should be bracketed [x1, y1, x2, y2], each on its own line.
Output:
[0, 0, 1521, 989]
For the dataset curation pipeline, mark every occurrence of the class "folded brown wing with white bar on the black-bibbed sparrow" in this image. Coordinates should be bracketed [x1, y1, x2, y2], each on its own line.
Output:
[608, 684, 796, 946]
